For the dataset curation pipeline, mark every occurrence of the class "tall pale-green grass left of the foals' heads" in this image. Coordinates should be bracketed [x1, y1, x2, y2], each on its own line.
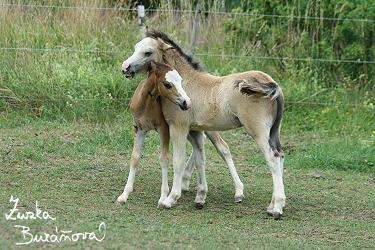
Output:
[0, 3, 141, 120]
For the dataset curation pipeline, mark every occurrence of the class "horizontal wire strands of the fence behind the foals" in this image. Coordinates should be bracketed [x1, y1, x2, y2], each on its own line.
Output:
[0, 2, 375, 107]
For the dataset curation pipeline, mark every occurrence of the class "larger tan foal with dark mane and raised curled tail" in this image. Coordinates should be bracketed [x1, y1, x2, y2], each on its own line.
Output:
[122, 31, 286, 219]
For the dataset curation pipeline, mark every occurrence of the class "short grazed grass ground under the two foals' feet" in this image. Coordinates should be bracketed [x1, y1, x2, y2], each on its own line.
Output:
[0, 116, 375, 249]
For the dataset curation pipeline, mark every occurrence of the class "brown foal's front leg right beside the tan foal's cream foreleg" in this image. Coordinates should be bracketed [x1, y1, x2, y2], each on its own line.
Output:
[158, 124, 170, 207]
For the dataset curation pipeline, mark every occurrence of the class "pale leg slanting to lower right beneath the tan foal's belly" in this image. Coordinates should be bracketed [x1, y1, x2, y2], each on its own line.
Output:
[205, 131, 244, 202]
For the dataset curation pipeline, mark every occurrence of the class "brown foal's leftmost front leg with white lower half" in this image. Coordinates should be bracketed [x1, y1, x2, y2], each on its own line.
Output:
[117, 127, 147, 203]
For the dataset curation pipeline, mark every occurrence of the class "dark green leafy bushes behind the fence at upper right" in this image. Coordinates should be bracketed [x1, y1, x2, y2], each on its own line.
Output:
[223, 0, 375, 91]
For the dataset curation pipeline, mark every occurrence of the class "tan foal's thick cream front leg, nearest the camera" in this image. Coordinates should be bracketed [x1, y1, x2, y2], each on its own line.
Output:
[160, 126, 189, 208]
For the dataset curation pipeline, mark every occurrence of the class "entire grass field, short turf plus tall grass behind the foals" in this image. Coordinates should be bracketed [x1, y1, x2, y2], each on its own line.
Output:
[0, 0, 375, 249]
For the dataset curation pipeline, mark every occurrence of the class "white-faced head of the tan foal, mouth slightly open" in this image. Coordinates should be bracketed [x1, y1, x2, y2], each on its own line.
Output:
[122, 37, 173, 79]
